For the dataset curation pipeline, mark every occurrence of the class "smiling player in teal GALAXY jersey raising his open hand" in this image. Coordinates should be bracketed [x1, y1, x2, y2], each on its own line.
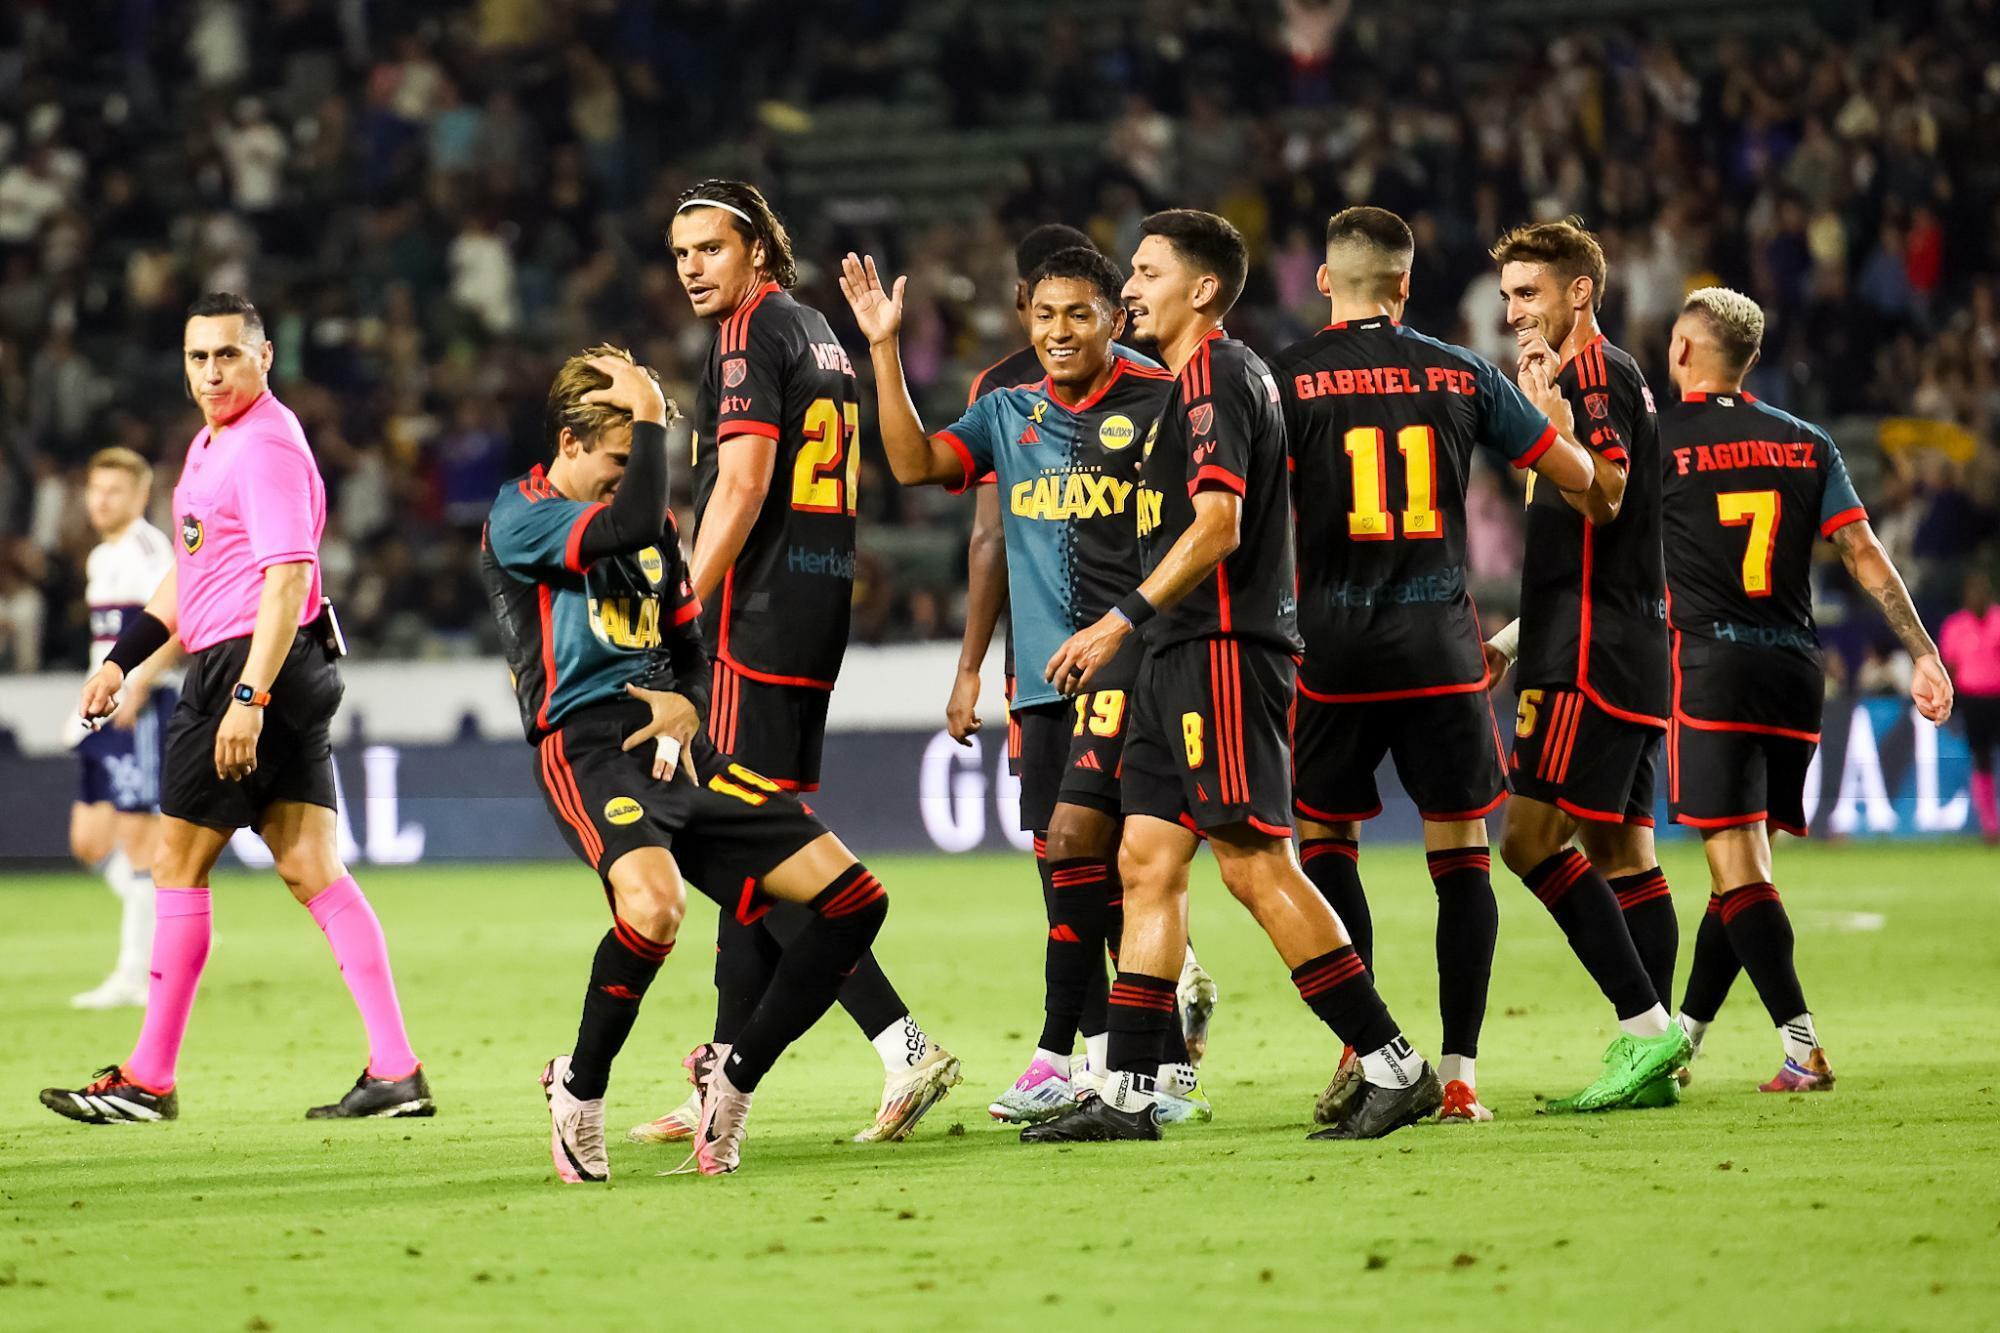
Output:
[840, 246, 1210, 1123]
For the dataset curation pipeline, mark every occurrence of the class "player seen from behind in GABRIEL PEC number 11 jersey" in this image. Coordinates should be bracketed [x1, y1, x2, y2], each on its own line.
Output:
[1270, 208, 1592, 1123]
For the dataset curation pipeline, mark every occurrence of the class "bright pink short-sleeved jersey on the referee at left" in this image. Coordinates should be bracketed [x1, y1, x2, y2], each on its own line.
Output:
[172, 388, 326, 652]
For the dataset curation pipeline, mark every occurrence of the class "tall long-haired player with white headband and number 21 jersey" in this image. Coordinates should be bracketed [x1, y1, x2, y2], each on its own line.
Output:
[632, 180, 960, 1143]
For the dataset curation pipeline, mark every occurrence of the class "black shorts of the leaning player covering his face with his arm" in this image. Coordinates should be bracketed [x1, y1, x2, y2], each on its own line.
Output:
[536, 705, 826, 921]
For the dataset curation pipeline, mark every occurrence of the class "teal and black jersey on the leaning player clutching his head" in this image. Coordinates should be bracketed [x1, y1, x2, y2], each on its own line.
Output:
[480, 466, 702, 743]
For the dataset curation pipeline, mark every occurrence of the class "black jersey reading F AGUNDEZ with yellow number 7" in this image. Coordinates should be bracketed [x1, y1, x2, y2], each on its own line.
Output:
[1660, 394, 1868, 739]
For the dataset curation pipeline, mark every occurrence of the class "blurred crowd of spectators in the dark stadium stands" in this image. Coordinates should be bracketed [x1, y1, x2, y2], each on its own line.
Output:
[0, 0, 2000, 687]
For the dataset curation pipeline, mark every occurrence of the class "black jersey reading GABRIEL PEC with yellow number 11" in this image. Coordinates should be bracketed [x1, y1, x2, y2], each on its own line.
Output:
[1272, 316, 1556, 703]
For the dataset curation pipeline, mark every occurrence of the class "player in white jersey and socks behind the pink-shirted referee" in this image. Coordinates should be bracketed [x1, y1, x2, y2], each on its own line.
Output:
[70, 448, 176, 1009]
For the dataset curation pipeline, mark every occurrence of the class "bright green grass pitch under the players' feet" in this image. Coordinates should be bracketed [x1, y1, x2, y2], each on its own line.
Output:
[0, 843, 2000, 1329]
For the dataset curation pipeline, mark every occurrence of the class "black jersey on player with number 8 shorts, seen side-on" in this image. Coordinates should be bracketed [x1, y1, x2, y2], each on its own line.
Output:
[1138, 328, 1300, 652]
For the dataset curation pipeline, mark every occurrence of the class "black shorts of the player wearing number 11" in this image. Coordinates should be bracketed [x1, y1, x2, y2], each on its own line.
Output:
[1292, 689, 1506, 825]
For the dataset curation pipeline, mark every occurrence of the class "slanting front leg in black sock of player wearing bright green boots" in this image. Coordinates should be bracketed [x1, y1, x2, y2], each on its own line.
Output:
[1500, 795, 1690, 1111]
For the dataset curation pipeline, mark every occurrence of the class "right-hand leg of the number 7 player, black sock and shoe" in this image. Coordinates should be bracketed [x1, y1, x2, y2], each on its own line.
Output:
[1690, 823, 1834, 1093]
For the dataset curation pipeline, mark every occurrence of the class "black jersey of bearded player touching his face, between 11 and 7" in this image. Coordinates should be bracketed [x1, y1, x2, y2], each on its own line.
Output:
[1516, 334, 1668, 727]
